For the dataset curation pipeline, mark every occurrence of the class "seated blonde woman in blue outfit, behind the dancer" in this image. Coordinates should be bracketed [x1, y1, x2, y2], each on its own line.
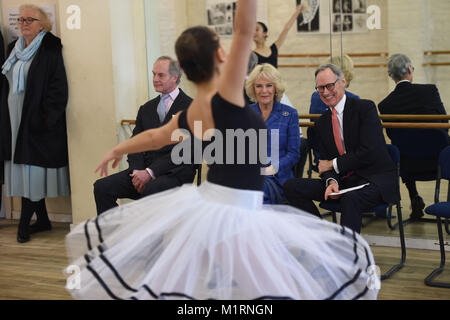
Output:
[245, 63, 300, 204]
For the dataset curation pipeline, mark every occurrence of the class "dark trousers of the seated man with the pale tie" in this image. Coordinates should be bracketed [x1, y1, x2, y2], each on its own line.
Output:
[94, 170, 183, 215]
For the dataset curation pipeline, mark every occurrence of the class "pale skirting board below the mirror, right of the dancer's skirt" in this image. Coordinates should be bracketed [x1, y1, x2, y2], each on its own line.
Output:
[362, 231, 450, 252]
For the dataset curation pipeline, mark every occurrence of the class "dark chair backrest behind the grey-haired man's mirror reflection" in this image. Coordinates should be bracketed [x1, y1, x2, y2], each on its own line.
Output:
[389, 128, 448, 160]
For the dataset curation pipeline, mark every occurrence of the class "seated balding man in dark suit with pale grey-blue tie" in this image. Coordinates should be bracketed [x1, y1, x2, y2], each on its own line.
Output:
[94, 56, 195, 214]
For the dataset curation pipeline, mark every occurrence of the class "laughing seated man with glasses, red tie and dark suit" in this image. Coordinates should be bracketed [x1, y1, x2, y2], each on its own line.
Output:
[284, 64, 400, 233]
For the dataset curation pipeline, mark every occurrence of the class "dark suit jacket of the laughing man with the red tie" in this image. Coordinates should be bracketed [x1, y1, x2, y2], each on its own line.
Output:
[316, 97, 400, 203]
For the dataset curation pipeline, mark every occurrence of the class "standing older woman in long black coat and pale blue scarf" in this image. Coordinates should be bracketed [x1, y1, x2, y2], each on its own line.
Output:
[0, 5, 69, 243]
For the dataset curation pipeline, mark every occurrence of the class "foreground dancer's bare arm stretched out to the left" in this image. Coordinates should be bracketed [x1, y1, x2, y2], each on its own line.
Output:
[95, 114, 180, 176]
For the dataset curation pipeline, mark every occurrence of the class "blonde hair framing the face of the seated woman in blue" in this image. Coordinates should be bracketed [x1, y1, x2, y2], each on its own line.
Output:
[245, 63, 286, 102]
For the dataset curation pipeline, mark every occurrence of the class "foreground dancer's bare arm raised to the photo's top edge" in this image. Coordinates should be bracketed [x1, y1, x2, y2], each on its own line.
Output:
[218, 0, 257, 107]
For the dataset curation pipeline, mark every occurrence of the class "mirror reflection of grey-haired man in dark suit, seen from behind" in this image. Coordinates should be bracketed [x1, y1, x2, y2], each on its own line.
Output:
[378, 54, 447, 219]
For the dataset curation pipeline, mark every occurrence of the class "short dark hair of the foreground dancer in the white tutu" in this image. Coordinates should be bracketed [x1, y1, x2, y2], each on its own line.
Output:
[175, 26, 219, 83]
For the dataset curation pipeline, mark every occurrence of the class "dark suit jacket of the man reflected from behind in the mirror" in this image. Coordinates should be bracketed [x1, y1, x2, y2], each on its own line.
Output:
[378, 81, 448, 138]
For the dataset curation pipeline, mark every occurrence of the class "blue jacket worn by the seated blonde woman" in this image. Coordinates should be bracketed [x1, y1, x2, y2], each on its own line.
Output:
[250, 102, 300, 186]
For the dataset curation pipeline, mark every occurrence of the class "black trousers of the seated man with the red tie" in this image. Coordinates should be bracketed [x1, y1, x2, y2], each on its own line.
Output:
[283, 176, 384, 233]
